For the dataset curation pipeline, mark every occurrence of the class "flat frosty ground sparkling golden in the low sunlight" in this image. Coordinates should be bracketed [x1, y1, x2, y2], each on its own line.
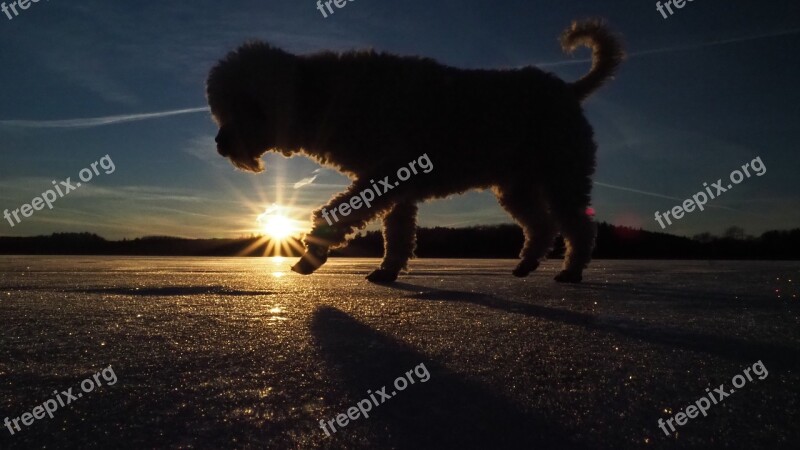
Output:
[0, 257, 800, 449]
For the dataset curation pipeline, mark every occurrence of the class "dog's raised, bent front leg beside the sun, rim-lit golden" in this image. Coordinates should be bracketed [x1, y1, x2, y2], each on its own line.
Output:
[292, 177, 392, 275]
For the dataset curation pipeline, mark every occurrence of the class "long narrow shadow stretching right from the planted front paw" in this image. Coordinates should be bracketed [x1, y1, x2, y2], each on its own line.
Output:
[378, 283, 800, 369]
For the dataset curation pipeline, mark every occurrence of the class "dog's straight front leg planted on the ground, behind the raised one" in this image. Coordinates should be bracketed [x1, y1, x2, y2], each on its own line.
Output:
[367, 202, 417, 283]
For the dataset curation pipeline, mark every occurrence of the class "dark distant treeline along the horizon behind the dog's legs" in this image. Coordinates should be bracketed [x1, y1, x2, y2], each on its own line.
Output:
[0, 223, 800, 260]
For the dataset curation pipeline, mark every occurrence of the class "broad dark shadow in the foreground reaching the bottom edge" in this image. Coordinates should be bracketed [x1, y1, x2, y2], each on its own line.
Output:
[311, 307, 576, 449]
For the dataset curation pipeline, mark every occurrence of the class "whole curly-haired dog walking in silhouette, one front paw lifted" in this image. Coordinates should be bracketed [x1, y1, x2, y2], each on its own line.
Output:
[206, 21, 623, 282]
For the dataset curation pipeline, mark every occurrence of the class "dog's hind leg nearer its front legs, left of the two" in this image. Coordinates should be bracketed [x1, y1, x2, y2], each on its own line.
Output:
[495, 184, 556, 277]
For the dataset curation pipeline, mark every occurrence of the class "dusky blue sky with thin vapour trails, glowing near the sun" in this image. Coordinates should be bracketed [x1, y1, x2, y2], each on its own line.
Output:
[0, 0, 800, 238]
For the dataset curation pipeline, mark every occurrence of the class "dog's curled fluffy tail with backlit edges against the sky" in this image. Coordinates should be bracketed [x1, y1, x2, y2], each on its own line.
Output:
[561, 20, 625, 100]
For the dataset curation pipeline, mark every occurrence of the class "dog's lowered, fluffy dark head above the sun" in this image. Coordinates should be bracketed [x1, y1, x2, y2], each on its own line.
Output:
[206, 42, 296, 172]
